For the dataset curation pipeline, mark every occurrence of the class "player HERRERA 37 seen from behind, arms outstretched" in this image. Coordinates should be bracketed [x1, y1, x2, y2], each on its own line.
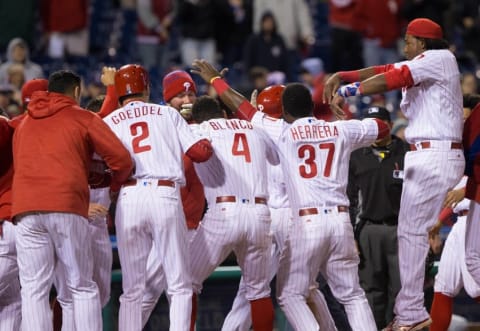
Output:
[192, 60, 388, 330]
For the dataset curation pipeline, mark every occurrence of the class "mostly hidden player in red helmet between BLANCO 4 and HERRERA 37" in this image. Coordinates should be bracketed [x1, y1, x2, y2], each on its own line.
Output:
[222, 85, 336, 331]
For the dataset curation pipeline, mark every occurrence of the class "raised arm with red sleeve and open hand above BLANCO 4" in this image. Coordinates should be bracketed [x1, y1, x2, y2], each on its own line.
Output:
[191, 60, 257, 120]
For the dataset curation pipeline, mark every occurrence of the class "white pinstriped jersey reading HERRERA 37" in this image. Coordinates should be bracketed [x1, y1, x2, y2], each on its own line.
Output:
[252, 112, 378, 208]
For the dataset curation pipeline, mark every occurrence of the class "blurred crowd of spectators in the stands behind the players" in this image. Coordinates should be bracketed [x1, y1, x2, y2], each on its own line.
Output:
[0, 0, 480, 136]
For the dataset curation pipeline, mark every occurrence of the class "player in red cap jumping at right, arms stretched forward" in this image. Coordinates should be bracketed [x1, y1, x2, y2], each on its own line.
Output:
[324, 18, 465, 331]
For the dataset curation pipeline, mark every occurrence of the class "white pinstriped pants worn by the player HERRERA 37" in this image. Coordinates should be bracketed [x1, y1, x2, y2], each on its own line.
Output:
[277, 207, 376, 331]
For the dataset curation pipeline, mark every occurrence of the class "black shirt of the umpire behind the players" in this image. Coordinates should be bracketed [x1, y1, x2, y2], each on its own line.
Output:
[347, 135, 409, 225]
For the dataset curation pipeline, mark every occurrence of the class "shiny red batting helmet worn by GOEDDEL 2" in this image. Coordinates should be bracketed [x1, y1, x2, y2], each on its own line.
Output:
[115, 64, 149, 98]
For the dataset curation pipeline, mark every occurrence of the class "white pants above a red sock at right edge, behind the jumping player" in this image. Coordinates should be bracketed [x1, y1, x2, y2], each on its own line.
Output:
[434, 216, 480, 298]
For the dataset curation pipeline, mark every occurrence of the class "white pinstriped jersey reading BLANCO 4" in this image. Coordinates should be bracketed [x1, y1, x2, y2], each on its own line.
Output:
[192, 118, 279, 203]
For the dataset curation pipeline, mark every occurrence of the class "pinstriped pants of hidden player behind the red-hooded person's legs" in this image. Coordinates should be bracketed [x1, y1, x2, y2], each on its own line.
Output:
[53, 217, 112, 331]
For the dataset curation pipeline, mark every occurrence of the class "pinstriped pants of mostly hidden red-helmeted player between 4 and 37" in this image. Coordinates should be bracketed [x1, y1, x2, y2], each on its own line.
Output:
[222, 208, 336, 331]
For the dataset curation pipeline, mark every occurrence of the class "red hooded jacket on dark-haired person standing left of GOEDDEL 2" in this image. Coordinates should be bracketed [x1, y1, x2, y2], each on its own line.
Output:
[12, 92, 133, 217]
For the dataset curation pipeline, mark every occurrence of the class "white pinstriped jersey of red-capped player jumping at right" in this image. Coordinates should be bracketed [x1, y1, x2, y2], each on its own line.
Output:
[395, 50, 463, 143]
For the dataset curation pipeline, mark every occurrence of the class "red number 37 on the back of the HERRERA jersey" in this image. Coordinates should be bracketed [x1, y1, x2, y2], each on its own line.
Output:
[298, 143, 335, 178]
